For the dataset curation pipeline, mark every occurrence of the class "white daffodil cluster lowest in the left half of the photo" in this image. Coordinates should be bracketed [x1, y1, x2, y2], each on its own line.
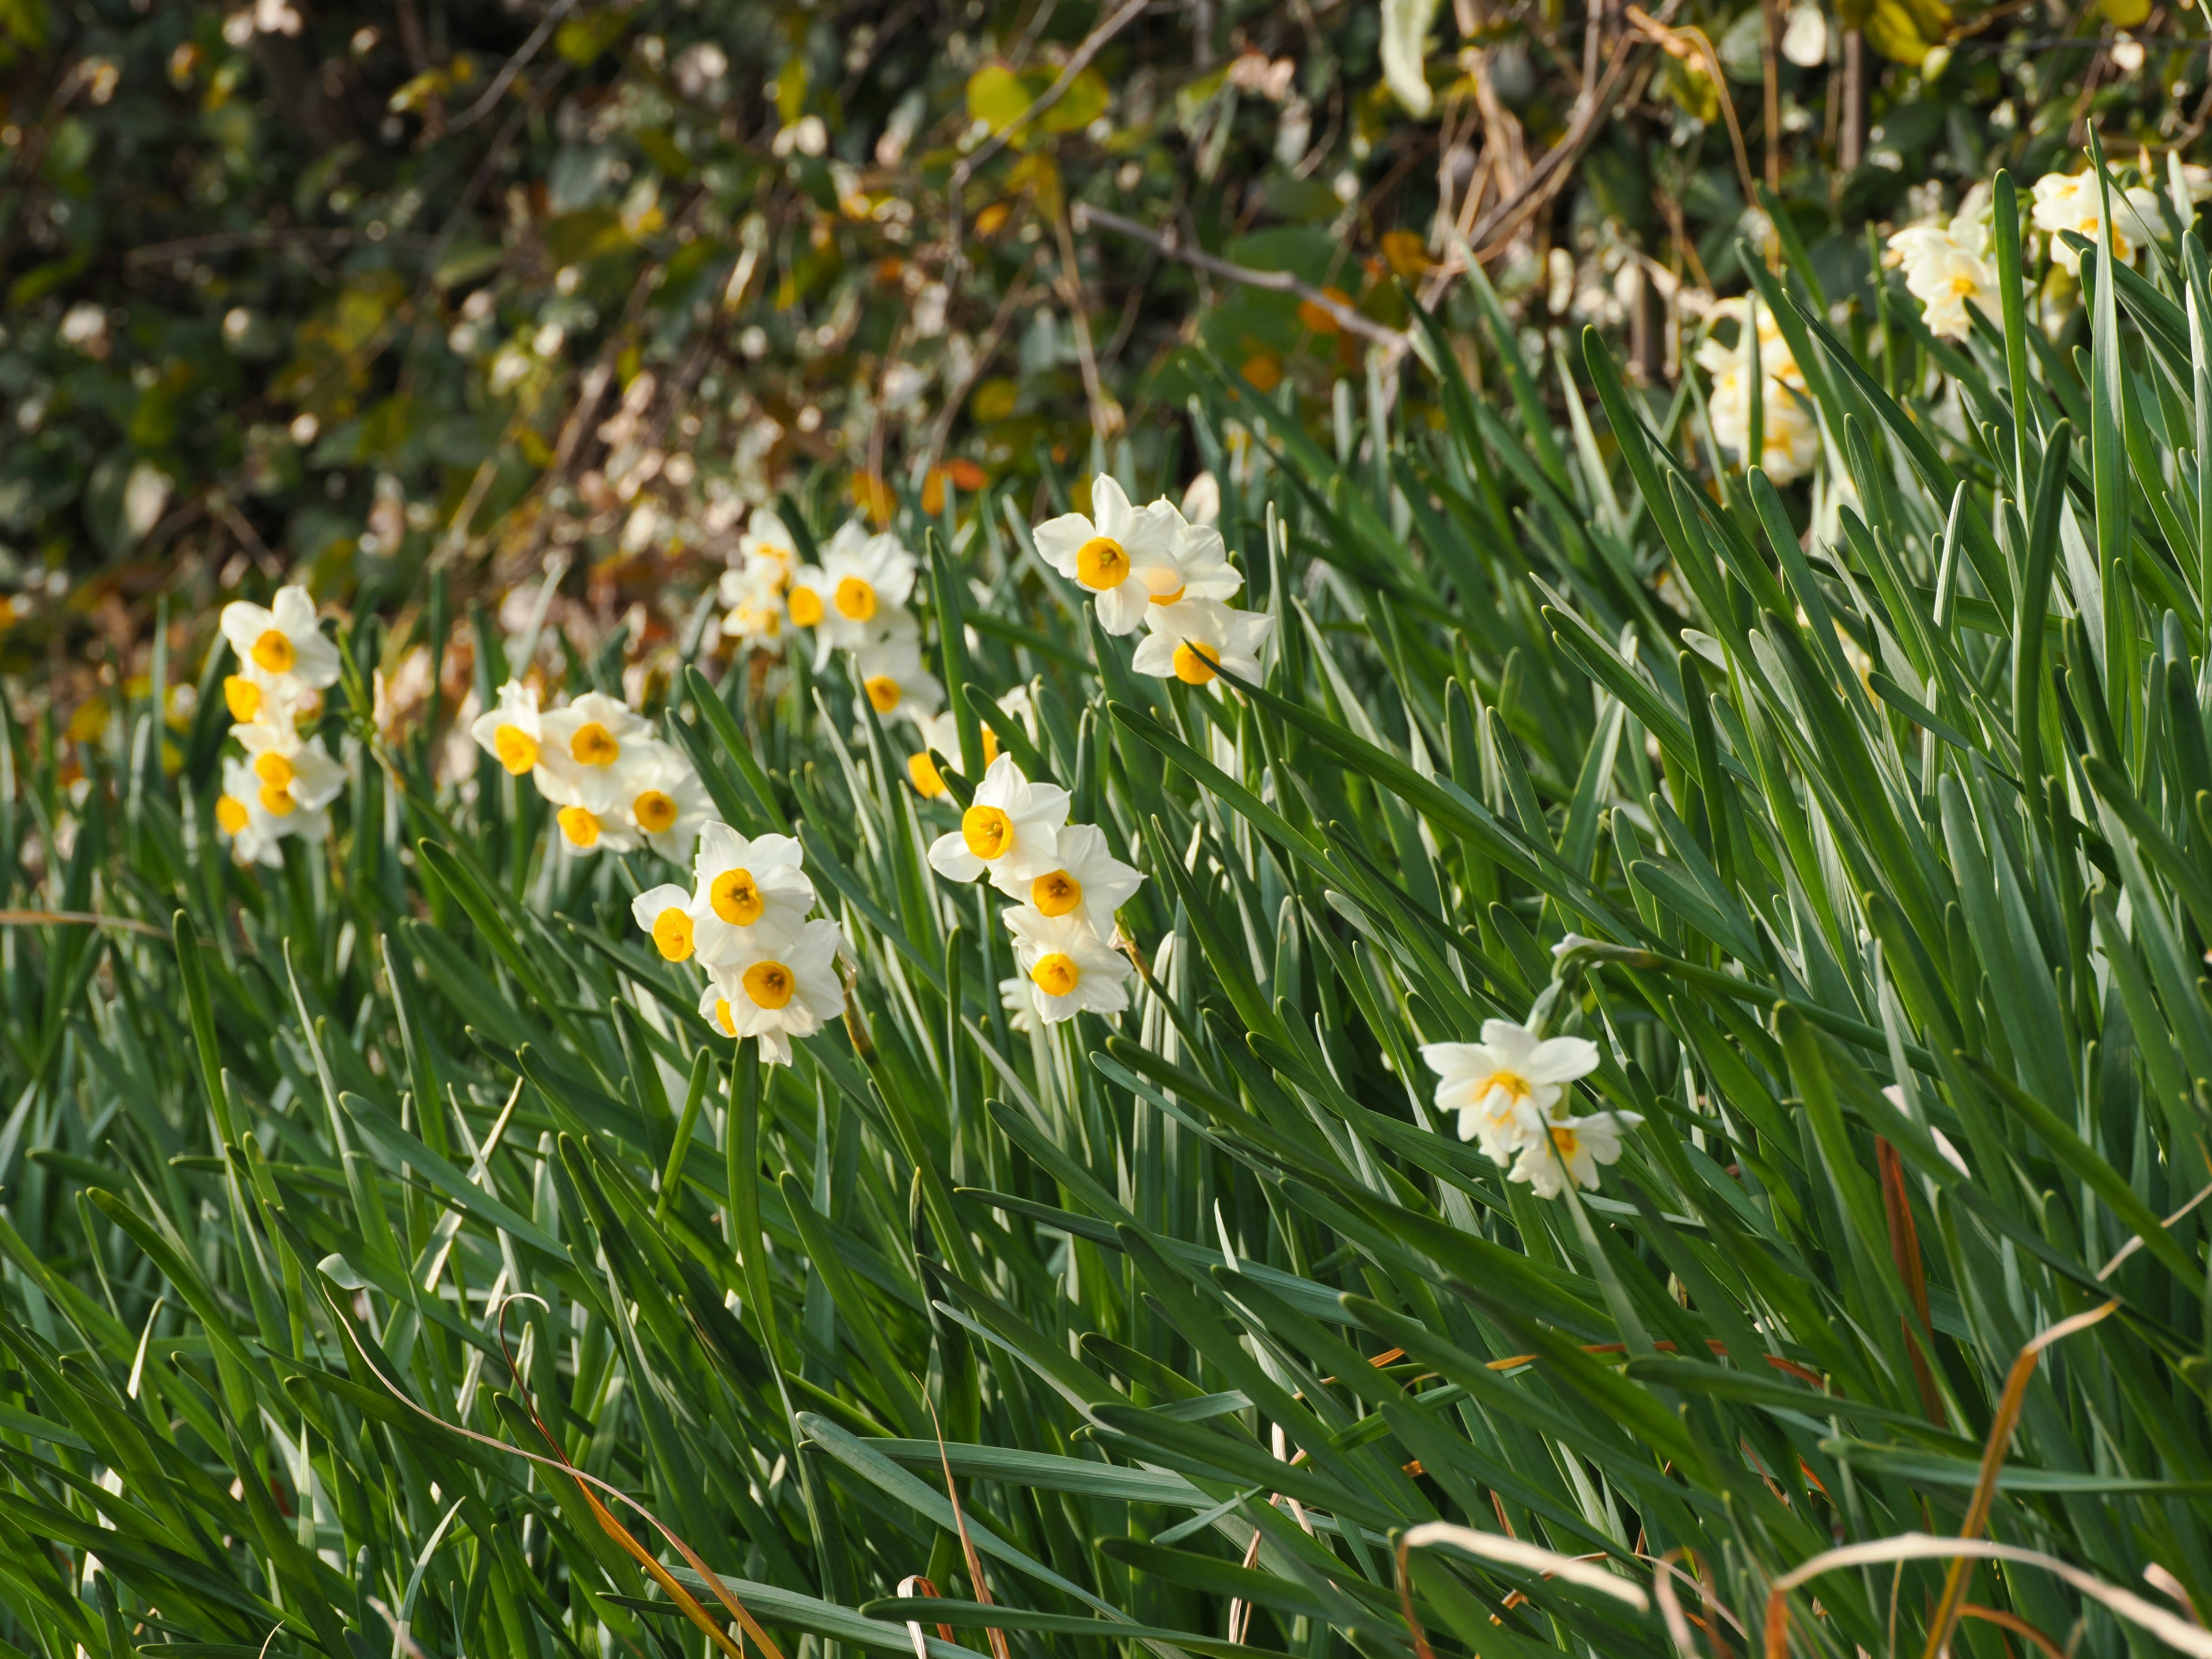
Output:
[630, 821, 845, 1066]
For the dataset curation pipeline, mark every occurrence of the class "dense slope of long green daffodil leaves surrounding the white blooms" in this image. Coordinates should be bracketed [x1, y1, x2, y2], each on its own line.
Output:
[0, 149, 2212, 1659]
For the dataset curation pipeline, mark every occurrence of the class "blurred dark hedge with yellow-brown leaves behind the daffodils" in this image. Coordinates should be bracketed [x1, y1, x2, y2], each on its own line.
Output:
[0, 0, 2212, 712]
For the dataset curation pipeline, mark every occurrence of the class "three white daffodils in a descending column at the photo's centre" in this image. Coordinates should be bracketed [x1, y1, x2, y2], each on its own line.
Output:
[929, 750, 1143, 1024]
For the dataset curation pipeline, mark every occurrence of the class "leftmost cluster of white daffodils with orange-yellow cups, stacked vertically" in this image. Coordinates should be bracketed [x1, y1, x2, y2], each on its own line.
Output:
[214, 588, 345, 865]
